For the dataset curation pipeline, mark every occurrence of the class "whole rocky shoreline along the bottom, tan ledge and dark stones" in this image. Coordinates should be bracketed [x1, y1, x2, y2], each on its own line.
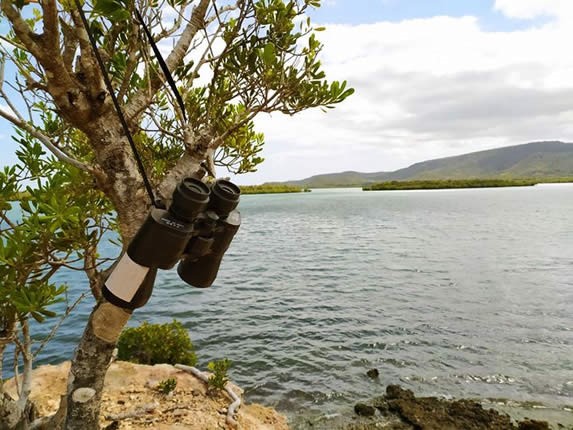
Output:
[5, 361, 573, 430]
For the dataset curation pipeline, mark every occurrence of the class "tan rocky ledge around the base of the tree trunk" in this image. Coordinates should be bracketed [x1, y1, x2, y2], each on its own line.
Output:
[5, 361, 288, 430]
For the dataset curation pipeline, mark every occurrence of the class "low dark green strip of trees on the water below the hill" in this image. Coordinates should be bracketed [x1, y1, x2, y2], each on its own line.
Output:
[362, 179, 540, 191]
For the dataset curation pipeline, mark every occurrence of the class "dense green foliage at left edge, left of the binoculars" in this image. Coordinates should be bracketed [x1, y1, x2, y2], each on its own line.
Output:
[0, 132, 110, 329]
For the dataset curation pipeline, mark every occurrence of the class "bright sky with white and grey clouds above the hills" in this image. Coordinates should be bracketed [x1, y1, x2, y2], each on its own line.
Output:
[0, 0, 573, 184]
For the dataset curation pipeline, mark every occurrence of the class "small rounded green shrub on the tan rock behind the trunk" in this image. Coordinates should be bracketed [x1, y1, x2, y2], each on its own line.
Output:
[117, 320, 197, 366]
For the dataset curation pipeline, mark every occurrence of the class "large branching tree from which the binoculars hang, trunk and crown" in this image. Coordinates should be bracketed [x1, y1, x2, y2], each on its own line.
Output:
[0, 0, 352, 429]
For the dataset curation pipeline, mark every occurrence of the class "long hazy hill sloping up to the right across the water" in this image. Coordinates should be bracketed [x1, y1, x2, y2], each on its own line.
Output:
[272, 141, 573, 188]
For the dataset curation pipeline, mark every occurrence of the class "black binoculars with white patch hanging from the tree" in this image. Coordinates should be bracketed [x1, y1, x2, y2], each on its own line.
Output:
[102, 178, 241, 309]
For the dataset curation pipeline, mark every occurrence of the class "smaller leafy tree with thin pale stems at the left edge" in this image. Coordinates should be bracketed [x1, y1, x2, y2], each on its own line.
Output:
[0, 136, 111, 429]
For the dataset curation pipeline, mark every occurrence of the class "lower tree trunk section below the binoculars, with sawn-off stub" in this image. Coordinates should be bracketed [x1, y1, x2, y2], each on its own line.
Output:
[64, 300, 131, 430]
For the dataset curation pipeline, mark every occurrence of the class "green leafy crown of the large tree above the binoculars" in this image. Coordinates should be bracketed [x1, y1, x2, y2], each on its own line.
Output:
[1, 0, 354, 179]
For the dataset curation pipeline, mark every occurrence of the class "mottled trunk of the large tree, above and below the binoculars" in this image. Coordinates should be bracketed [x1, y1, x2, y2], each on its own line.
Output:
[61, 115, 206, 430]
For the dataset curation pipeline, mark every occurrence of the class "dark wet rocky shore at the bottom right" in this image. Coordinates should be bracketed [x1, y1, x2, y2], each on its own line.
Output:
[287, 385, 573, 430]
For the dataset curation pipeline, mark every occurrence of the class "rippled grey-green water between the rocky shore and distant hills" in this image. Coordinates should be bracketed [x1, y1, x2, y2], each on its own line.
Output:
[7, 185, 573, 417]
